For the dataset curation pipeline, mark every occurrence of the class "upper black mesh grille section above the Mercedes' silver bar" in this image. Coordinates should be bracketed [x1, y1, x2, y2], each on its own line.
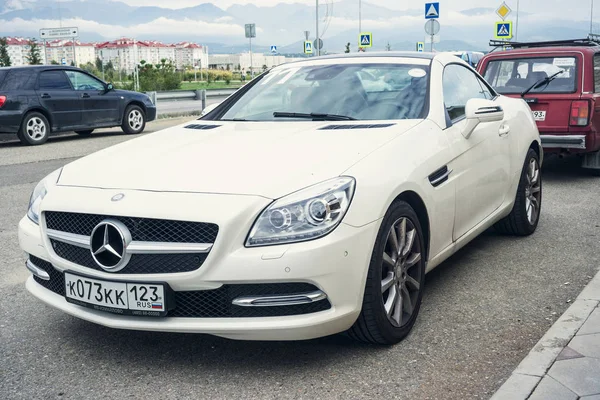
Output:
[44, 211, 219, 243]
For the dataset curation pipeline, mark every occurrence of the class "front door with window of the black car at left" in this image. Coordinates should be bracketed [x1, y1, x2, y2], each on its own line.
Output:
[66, 70, 121, 128]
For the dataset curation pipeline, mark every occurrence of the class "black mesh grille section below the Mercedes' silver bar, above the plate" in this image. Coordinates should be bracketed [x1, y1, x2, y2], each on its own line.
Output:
[50, 240, 208, 274]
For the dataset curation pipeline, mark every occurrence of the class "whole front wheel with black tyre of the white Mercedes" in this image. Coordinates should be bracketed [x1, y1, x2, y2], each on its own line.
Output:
[348, 201, 425, 344]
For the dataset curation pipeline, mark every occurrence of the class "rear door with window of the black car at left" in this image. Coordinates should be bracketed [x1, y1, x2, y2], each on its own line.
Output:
[36, 69, 83, 130]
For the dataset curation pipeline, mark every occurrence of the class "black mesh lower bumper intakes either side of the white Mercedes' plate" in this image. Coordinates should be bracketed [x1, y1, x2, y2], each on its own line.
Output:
[30, 262, 331, 318]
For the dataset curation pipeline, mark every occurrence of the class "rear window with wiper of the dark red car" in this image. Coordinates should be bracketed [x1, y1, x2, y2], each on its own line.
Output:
[484, 57, 577, 94]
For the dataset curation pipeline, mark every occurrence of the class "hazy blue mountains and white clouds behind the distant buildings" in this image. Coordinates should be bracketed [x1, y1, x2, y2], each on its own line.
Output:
[0, 0, 589, 54]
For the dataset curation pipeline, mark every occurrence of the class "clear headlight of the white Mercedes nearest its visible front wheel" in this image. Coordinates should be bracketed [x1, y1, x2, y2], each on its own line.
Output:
[246, 176, 355, 247]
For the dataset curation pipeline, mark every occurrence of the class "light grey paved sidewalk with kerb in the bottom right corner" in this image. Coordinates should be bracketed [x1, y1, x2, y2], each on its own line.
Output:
[492, 272, 600, 400]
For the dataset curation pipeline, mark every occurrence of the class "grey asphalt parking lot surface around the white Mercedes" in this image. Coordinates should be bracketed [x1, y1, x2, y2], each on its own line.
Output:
[0, 119, 600, 399]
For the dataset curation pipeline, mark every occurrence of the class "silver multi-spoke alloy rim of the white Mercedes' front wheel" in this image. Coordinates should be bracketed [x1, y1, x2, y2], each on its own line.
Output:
[381, 217, 423, 327]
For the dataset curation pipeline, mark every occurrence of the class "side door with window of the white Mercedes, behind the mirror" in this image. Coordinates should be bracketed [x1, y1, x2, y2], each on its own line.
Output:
[443, 64, 510, 240]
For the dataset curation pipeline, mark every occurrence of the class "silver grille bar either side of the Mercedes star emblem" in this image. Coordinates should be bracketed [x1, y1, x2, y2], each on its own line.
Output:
[46, 229, 213, 254]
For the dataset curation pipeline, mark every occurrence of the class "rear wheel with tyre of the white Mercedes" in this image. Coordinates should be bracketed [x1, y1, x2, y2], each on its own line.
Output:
[495, 149, 542, 236]
